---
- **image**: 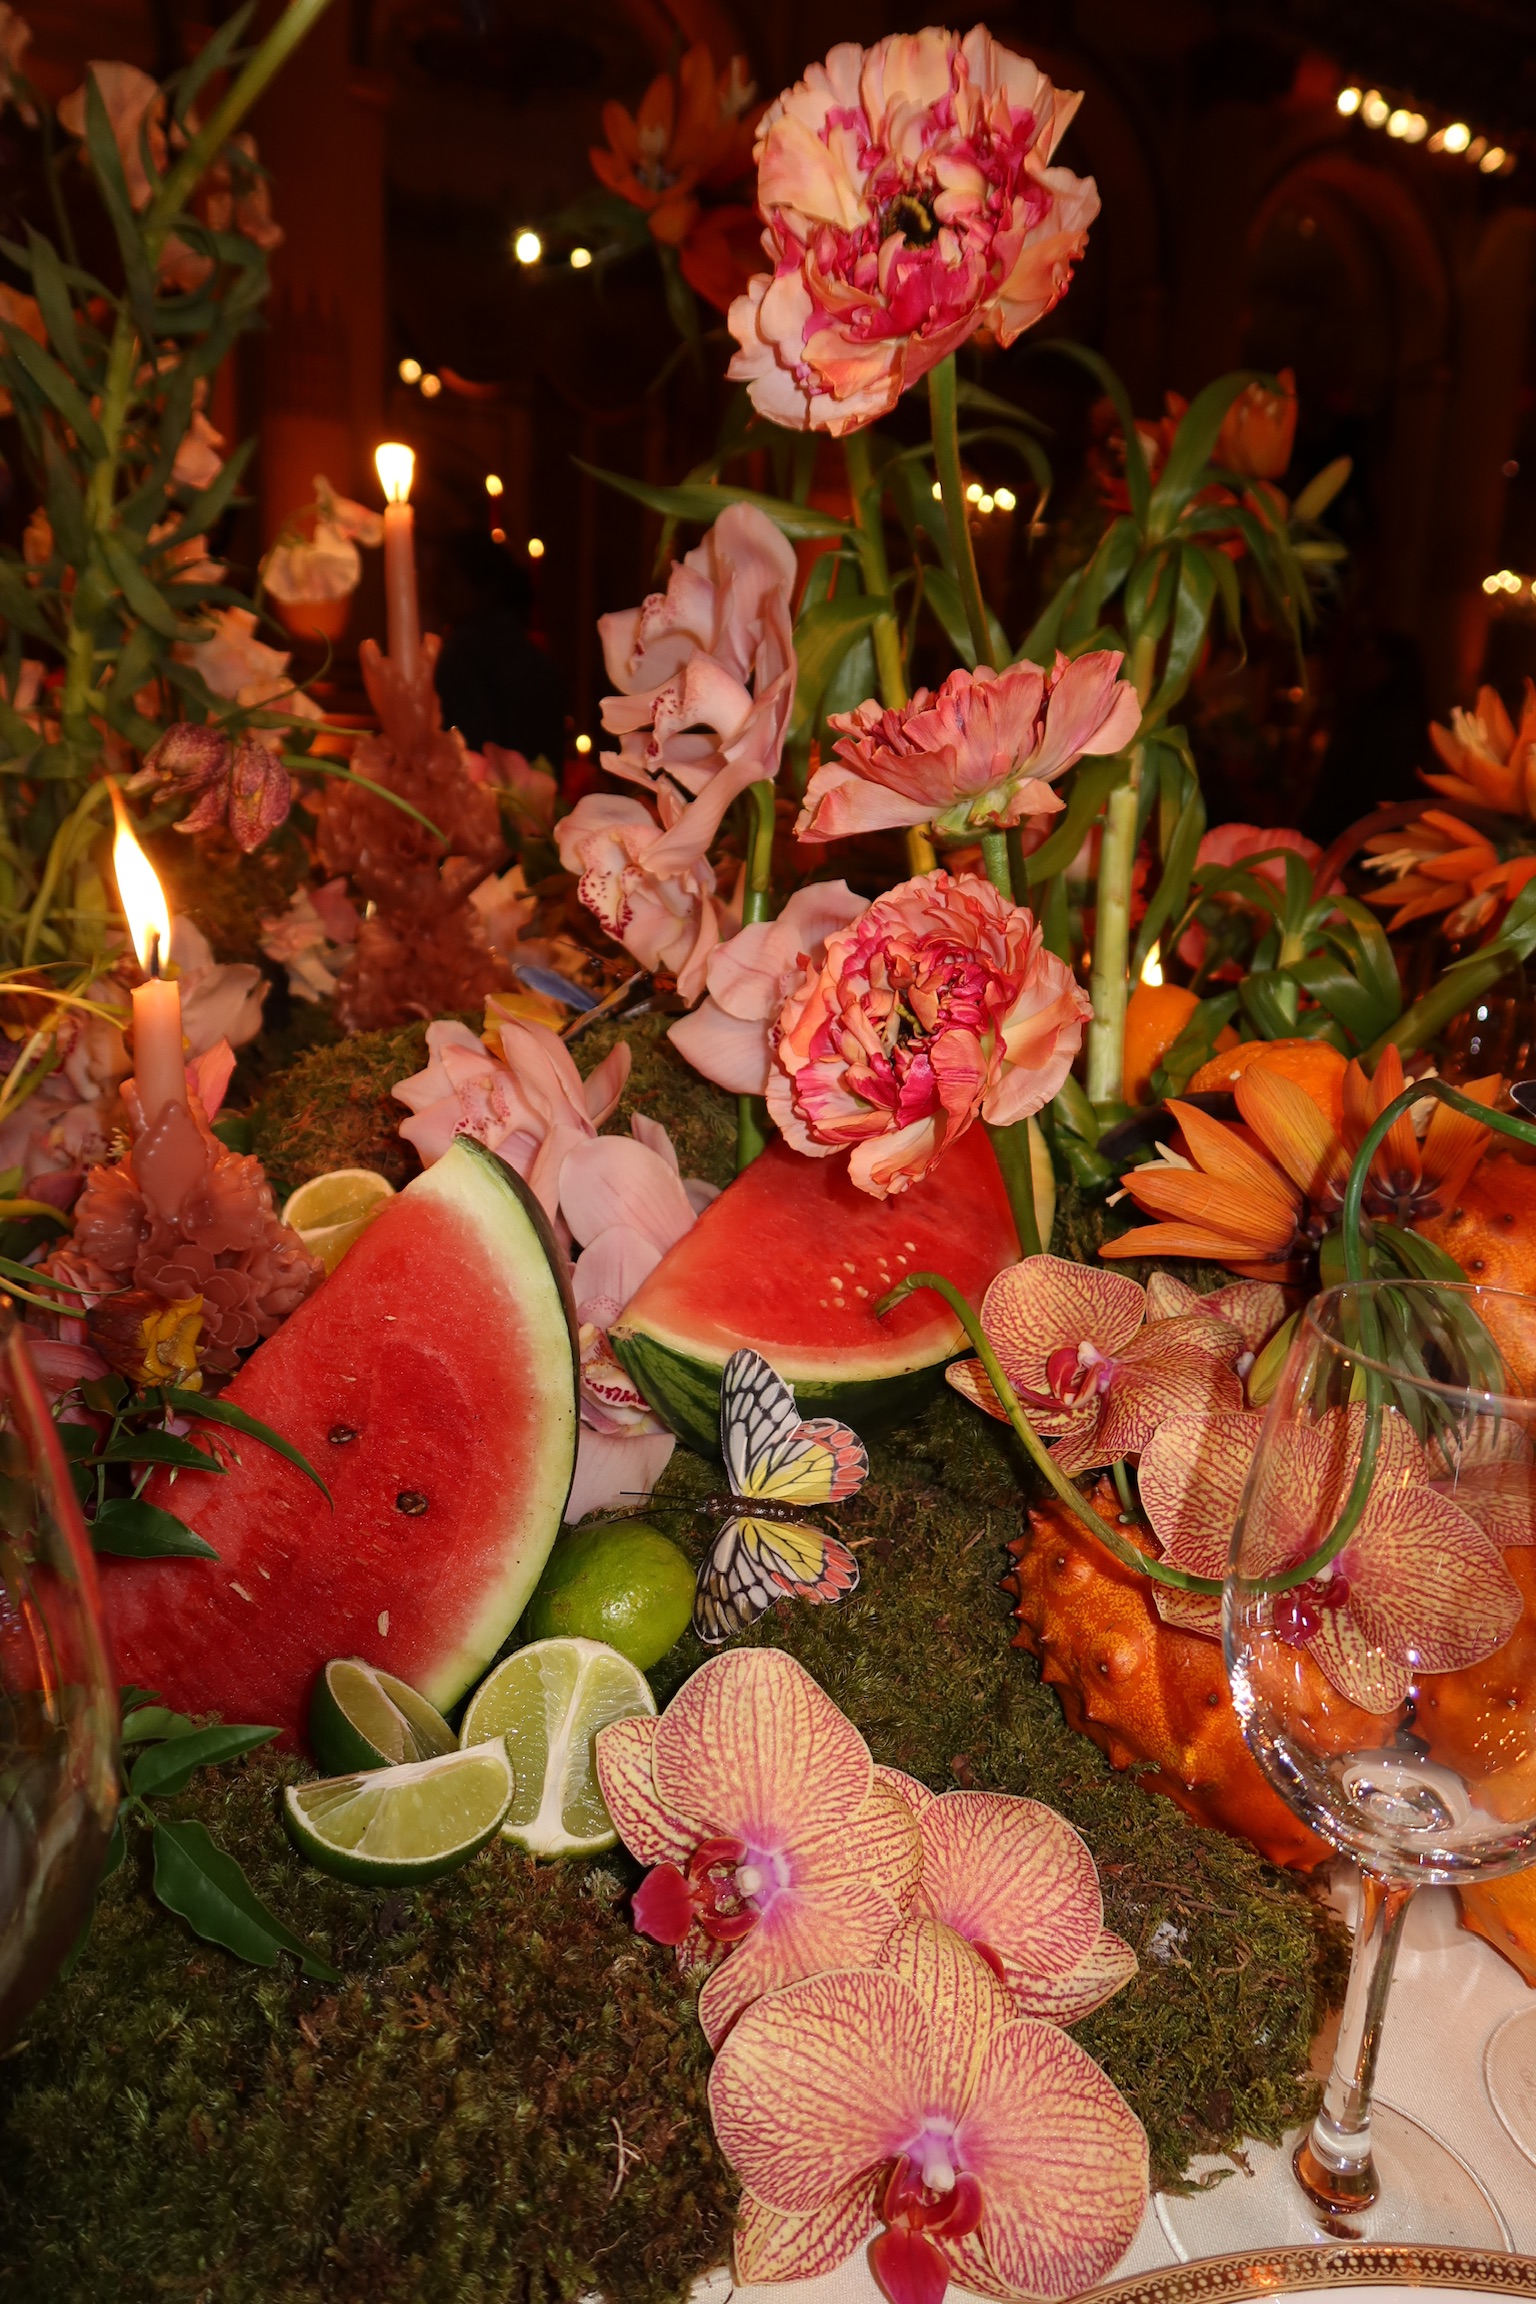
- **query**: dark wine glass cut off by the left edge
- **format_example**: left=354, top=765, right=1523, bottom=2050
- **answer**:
left=0, top=1297, right=117, bottom=2044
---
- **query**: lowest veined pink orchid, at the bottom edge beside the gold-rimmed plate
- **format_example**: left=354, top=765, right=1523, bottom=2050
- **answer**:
left=709, top=1919, right=1147, bottom=2304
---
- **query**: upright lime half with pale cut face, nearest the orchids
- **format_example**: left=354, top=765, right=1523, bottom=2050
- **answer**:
left=469, top=1640, right=656, bottom=1857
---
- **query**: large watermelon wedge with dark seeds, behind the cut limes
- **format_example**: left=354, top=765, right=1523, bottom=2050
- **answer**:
left=99, top=1136, right=576, bottom=1737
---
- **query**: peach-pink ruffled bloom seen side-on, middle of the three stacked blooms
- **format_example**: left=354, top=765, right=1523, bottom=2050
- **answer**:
left=794, top=647, right=1142, bottom=841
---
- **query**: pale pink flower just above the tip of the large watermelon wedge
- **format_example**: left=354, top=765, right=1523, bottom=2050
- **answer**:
left=391, top=1016, right=629, bottom=1221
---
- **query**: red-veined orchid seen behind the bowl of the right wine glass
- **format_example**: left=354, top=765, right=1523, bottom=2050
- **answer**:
left=1138, top=1408, right=1522, bottom=1712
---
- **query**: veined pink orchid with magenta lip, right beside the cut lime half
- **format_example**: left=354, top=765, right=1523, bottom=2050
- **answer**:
left=596, top=1647, right=919, bottom=2048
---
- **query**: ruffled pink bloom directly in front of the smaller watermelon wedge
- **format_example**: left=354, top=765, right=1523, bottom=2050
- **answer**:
left=767, top=871, right=1092, bottom=1200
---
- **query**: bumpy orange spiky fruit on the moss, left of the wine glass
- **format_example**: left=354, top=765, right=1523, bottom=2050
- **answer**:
left=1006, top=1481, right=1338, bottom=1871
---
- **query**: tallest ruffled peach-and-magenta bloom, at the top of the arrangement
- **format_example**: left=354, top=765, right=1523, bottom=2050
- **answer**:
left=730, top=25, right=1098, bottom=433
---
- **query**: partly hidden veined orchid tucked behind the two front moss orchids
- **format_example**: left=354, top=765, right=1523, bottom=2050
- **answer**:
left=884, top=1769, right=1135, bottom=2023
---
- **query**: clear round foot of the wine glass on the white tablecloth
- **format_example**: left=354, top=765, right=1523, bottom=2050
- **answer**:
left=1156, top=2101, right=1513, bottom=2263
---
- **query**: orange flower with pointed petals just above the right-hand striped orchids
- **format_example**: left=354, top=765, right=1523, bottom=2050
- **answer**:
left=1098, top=1048, right=1504, bottom=1281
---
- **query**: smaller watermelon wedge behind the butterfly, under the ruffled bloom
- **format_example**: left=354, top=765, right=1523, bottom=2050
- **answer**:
left=613, top=1129, right=1018, bottom=1456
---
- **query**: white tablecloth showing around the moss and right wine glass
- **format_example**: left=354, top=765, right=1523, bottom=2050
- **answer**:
left=695, top=1889, right=1536, bottom=2304
